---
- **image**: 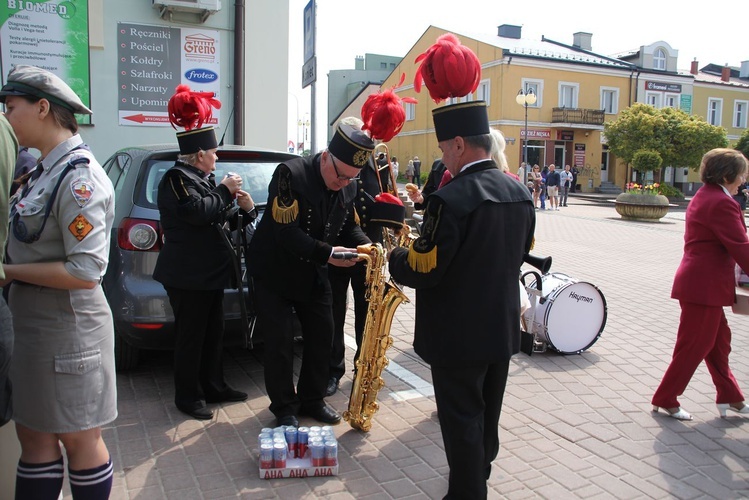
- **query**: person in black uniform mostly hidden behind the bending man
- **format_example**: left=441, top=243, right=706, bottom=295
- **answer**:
left=325, top=153, right=387, bottom=396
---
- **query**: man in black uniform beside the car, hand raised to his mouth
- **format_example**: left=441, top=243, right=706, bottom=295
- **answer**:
left=153, top=90, right=257, bottom=420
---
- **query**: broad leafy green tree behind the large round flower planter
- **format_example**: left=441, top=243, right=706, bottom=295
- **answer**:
left=604, top=103, right=728, bottom=184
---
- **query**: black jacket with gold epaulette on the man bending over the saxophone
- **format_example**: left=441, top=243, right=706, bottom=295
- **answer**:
left=247, top=154, right=369, bottom=301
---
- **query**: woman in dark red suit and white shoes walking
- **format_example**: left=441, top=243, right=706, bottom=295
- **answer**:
left=652, top=149, right=749, bottom=420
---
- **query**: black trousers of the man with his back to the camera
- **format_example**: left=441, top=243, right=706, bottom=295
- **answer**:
left=432, top=360, right=510, bottom=500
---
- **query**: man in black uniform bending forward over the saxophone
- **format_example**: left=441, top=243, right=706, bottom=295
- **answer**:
left=247, top=123, right=374, bottom=426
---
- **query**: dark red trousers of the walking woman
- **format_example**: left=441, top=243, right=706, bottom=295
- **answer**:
left=653, top=301, right=744, bottom=408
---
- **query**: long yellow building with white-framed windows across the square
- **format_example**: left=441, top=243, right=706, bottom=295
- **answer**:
left=358, top=25, right=749, bottom=193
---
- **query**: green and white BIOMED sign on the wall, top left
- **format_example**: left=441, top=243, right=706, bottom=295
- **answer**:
left=0, top=0, right=91, bottom=124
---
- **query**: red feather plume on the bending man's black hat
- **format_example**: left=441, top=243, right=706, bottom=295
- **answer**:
left=361, top=73, right=418, bottom=142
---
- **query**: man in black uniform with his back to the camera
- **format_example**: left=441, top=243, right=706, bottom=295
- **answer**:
left=389, top=101, right=535, bottom=499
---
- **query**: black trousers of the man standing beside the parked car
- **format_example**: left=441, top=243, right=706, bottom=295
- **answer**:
left=164, top=287, right=228, bottom=408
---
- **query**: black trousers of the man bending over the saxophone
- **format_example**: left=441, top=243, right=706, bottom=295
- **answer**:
left=255, top=278, right=333, bottom=418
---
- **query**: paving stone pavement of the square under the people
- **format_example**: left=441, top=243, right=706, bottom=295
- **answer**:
left=71, top=198, right=749, bottom=500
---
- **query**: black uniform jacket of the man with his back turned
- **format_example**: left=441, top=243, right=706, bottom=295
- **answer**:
left=389, top=160, right=536, bottom=366
